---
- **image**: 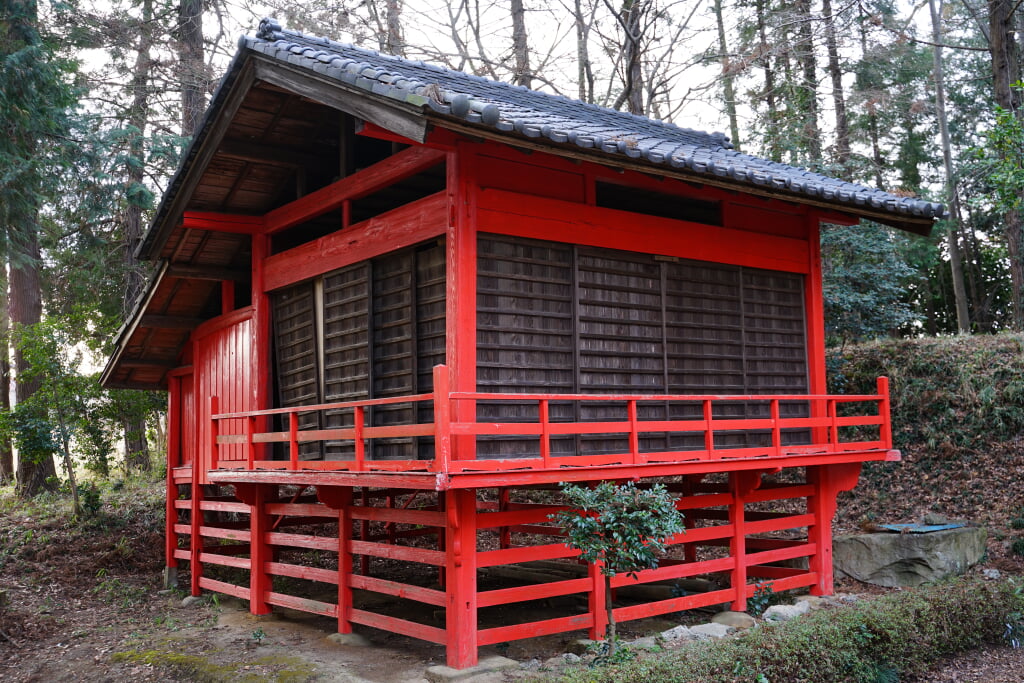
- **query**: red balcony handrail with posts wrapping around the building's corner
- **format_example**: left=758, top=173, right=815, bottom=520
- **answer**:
left=203, top=366, right=892, bottom=472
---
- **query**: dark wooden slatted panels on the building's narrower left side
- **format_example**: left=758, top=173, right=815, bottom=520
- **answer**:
left=271, top=240, right=445, bottom=460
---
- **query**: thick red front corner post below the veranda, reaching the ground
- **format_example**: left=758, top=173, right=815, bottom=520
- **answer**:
left=444, top=489, right=477, bottom=669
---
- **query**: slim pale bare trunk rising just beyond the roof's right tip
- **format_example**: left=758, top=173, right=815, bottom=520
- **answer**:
left=929, top=0, right=971, bottom=334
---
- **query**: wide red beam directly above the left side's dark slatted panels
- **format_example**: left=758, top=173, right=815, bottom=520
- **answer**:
left=263, top=192, right=446, bottom=291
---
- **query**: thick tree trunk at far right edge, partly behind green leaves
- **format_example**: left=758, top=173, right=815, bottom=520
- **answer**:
left=988, top=0, right=1024, bottom=330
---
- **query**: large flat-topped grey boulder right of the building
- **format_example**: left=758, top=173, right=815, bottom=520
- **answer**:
left=833, top=527, right=986, bottom=588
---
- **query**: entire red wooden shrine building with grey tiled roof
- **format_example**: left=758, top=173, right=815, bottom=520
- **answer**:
left=104, top=20, right=942, bottom=668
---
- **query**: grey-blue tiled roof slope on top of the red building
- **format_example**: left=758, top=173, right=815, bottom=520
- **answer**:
left=240, top=19, right=944, bottom=220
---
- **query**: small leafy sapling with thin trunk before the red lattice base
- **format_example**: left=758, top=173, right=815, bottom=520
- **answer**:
left=550, top=481, right=685, bottom=657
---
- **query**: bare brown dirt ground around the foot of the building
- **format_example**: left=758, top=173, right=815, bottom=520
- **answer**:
left=0, top=483, right=1024, bottom=683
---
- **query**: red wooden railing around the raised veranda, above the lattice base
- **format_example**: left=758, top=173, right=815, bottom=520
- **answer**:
left=210, top=366, right=892, bottom=472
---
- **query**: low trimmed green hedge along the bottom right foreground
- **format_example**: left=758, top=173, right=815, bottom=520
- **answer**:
left=565, top=581, right=1024, bottom=683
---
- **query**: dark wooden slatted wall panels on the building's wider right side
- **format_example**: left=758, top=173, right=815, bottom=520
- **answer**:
left=477, top=233, right=808, bottom=458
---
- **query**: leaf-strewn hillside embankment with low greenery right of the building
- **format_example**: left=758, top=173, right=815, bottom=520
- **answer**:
left=829, top=334, right=1024, bottom=571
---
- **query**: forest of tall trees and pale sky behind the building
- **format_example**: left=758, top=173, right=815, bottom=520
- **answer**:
left=0, top=0, right=1024, bottom=505
